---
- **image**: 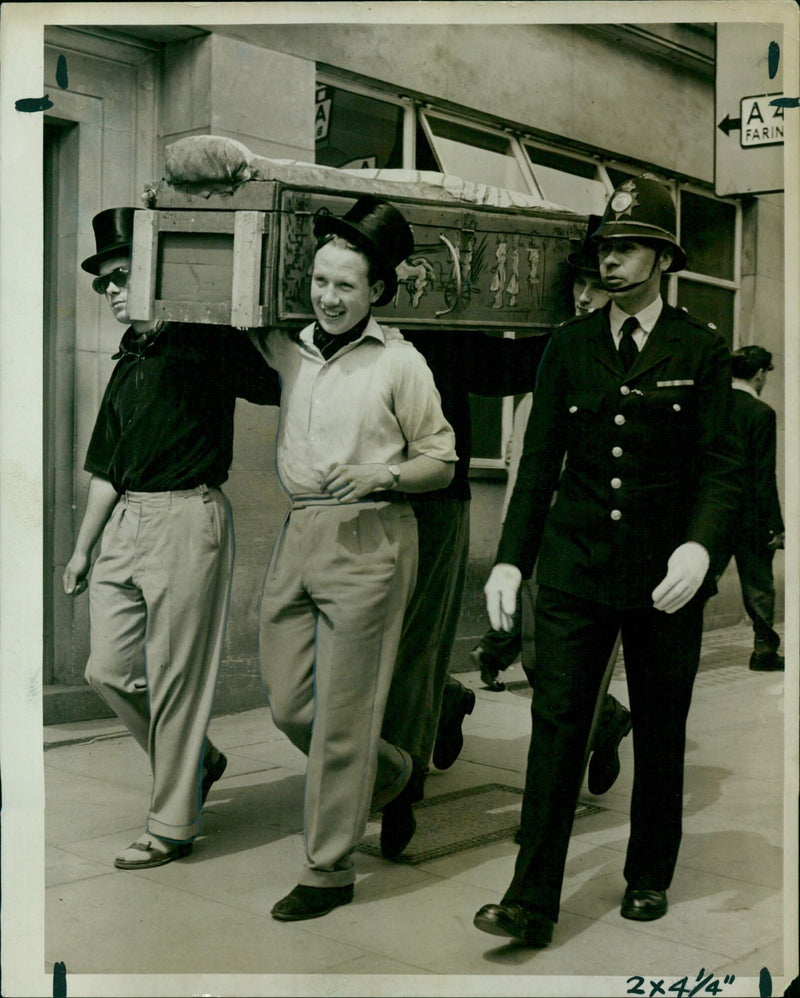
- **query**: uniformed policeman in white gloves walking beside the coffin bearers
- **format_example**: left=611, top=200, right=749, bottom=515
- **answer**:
left=475, top=175, right=739, bottom=946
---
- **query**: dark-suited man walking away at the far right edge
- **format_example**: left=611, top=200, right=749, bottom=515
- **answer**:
left=721, top=345, right=784, bottom=672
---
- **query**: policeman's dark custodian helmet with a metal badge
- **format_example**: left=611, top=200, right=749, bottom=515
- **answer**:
left=592, top=173, right=686, bottom=273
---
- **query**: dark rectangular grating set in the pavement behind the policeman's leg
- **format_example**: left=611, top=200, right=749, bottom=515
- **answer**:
left=358, top=783, right=605, bottom=866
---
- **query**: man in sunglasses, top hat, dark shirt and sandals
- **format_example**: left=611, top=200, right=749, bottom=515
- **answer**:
left=63, top=208, right=280, bottom=870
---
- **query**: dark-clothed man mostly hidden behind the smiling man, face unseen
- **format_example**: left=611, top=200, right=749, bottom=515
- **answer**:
left=381, top=329, right=547, bottom=859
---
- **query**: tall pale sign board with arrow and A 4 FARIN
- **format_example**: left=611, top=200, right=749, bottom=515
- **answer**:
left=714, top=21, right=785, bottom=197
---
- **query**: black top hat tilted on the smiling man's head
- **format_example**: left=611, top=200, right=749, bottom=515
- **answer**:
left=314, top=195, right=414, bottom=305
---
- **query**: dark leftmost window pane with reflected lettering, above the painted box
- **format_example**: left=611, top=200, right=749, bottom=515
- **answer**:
left=314, top=84, right=403, bottom=169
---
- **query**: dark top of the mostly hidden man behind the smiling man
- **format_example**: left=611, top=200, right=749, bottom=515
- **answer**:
left=403, top=329, right=550, bottom=500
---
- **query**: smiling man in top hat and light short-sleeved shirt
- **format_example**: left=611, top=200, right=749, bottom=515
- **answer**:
left=253, top=197, right=456, bottom=921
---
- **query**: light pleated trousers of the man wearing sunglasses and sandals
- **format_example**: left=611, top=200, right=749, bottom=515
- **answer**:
left=86, top=486, right=233, bottom=842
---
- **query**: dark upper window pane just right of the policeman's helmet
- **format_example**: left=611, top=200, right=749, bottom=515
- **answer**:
left=681, top=190, right=736, bottom=281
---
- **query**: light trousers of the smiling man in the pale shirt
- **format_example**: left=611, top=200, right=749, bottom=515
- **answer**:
left=259, top=502, right=417, bottom=887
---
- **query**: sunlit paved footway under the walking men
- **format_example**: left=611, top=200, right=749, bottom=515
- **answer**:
left=39, top=624, right=797, bottom=998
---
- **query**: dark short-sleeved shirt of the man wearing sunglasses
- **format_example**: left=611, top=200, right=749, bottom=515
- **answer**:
left=84, top=323, right=280, bottom=492
